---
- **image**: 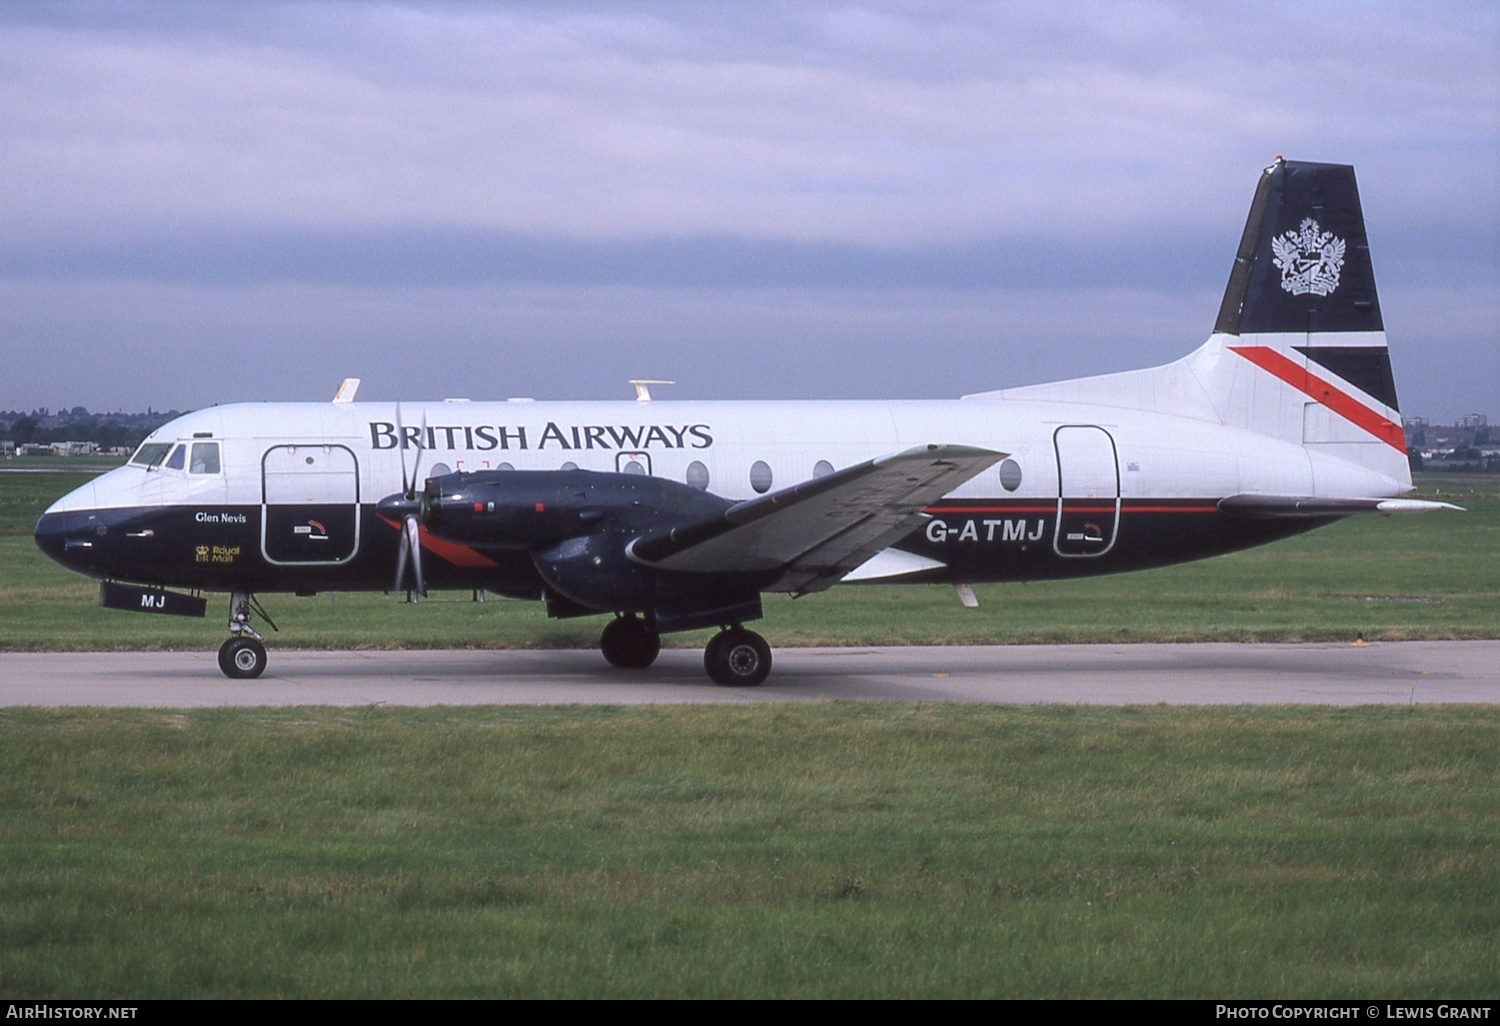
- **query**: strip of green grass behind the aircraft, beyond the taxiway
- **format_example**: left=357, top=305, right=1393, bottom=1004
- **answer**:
left=0, top=474, right=1500, bottom=651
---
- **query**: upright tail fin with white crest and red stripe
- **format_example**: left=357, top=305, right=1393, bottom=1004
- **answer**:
left=1187, top=159, right=1412, bottom=485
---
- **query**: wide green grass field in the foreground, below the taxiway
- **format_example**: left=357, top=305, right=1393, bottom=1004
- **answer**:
left=0, top=704, right=1500, bottom=998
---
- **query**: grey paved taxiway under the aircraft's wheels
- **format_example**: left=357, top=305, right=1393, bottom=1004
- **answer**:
left=0, top=641, right=1500, bottom=708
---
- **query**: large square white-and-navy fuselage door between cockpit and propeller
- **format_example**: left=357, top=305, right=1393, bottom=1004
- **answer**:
left=261, top=444, right=360, bottom=566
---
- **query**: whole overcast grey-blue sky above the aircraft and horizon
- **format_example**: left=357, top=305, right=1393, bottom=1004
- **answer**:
left=0, top=0, right=1500, bottom=420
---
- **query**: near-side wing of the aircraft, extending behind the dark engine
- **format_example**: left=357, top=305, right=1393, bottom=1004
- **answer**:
left=629, top=446, right=1007, bottom=594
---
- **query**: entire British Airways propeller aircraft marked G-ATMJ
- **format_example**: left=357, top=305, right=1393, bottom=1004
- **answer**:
left=36, top=159, right=1443, bottom=686
